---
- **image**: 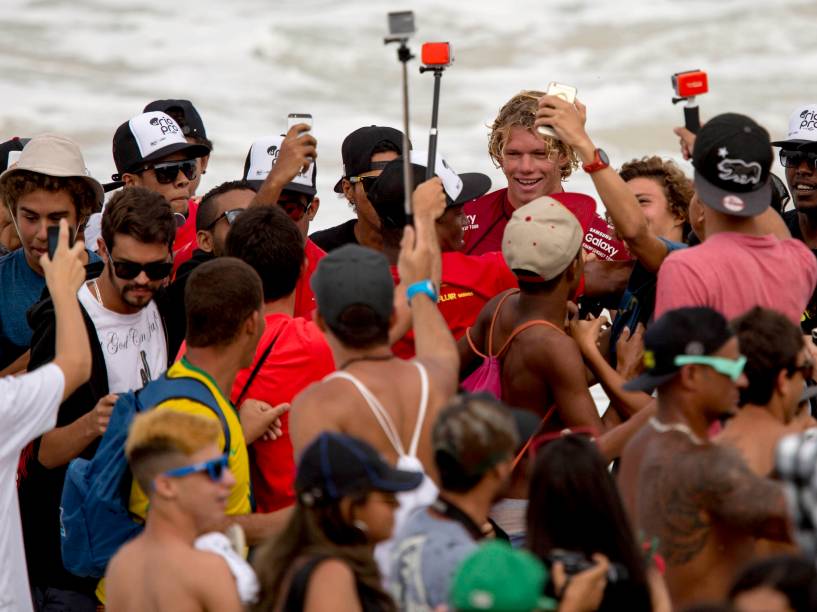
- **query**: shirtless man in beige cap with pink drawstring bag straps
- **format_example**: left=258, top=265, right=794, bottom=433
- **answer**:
left=459, top=196, right=604, bottom=431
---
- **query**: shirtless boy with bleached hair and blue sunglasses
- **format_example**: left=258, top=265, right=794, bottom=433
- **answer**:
left=105, top=410, right=242, bottom=612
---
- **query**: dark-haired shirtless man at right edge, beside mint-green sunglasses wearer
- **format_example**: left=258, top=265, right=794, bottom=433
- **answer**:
left=715, top=307, right=817, bottom=476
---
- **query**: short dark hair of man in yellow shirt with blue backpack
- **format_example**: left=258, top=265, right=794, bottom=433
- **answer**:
left=184, top=257, right=264, bottom=348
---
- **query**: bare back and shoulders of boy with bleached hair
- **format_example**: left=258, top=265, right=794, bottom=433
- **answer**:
left=105, top=533, right=242, bottom=612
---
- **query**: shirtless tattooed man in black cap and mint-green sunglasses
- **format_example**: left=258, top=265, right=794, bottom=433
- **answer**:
left=619, top=307, right=791, bottom=609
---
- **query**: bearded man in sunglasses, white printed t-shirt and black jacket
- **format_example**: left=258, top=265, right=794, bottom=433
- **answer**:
left=19, top=187, right=178, bottom=610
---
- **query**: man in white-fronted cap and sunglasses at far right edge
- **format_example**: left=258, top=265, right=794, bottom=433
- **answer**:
left=772, top=104, right=817, bottom=332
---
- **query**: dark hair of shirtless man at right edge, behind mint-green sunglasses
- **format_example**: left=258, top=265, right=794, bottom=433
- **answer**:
left=732, top=306, right=804, bottom=406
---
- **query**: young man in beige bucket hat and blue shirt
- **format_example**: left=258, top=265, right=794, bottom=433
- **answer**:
left=0, top=134, right=103, bottom=373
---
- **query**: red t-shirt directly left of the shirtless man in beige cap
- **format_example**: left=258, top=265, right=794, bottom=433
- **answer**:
left=391, top=252, right=517, bottom=359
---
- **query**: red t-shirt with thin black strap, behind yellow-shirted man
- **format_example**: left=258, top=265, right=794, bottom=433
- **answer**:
left=230, top=313, right=335, bottom=512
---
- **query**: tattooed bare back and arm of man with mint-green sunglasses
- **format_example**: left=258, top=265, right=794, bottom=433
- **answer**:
left=619, top=425, right=790, bottom=609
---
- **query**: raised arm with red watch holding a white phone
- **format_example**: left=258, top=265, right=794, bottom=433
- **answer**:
left=535, top=96, right=668, bottom=272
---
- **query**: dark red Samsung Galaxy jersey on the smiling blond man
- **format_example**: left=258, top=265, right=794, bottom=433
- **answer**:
left=463, top=187, right=631, bottom=261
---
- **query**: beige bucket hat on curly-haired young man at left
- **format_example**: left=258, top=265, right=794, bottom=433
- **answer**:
left=0, top=134, right=105, bottom=204
